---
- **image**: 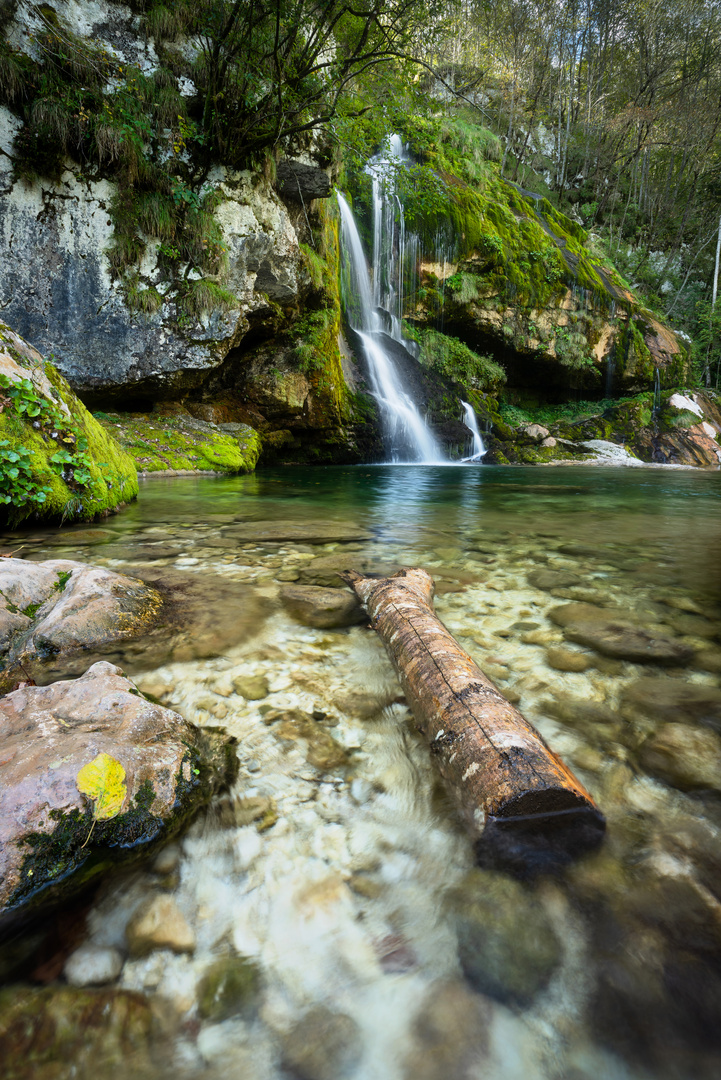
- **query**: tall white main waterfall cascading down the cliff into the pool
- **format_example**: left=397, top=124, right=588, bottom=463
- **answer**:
left=338, top=190, right=444, bottom=463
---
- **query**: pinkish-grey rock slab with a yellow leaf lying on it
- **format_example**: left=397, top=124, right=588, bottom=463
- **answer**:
left=0, top=661, right=236, bottom=919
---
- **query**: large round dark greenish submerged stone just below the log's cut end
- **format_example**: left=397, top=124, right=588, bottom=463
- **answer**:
left=450, top=869, right=560, bottom=1004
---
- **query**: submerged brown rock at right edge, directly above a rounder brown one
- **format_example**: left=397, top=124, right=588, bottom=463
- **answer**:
left=621, top=676, right=721, bottom=730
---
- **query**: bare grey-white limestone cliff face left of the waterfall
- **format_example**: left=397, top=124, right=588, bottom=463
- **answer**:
left=0, top=134, right=300, bottom=395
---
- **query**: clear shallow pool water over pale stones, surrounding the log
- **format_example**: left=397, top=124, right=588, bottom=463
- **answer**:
left=4, top=465, right=721, bottom=1080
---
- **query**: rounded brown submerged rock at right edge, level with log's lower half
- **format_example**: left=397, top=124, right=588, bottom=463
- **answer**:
left=639, top=724, right=721, bottom=792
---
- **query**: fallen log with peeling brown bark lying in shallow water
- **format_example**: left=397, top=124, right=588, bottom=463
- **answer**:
left=343, top=569, right=604, bottom=867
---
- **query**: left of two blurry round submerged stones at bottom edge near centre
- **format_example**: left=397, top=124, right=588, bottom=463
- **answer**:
left=282, top=1005, right=363, bottom=1080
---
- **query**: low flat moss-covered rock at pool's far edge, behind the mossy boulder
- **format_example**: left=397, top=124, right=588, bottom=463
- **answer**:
left=97, top=413, right=261, bottom=473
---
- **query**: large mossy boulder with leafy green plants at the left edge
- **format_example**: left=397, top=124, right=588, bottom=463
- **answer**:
left=0, top=323, right=138, bottom=524
